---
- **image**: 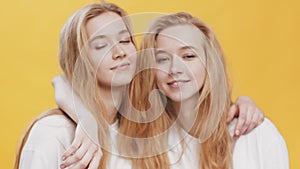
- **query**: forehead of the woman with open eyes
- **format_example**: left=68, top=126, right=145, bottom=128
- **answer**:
left=156, top=24, right=205, bottom=50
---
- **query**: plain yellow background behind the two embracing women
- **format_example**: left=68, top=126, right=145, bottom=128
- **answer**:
left=0, top=0, right=300, bottom=169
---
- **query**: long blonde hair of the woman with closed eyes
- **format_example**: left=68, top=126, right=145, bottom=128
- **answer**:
left=15, top=3, right=135, bottom=168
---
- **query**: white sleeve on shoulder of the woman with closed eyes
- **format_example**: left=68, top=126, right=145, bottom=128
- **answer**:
left=19, top=115, right=75, bottom=169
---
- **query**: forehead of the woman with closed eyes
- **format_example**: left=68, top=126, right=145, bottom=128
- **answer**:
left=86, top=12, right=127, bottom=37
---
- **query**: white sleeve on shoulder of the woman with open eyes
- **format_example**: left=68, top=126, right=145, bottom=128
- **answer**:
left=233, top=118, right=289, bottom=169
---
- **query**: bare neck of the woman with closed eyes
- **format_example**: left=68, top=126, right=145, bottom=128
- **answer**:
left=100, top=87, right=123, bottom=124
